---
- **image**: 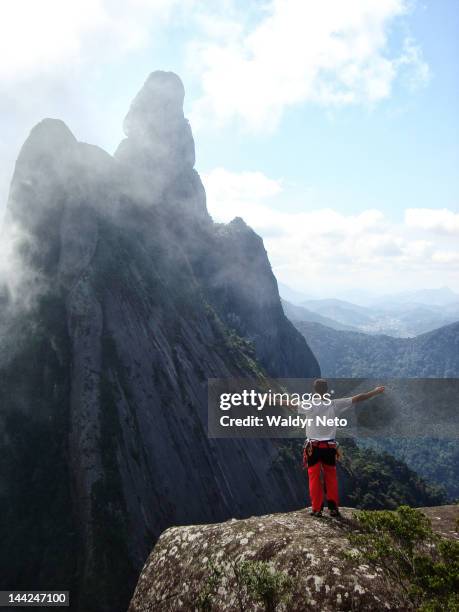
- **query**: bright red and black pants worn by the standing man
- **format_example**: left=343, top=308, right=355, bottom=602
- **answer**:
left=308, top=447, right=338, bottom=512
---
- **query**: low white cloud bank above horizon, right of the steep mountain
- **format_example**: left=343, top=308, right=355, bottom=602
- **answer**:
left=203, top=168, right=459, bottom=294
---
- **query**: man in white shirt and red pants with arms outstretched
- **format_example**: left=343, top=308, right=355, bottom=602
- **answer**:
left=282, top=378, right=384, bottom=517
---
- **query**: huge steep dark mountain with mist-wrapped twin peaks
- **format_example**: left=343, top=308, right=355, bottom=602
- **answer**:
left=0, top=72, right=319, bottom=612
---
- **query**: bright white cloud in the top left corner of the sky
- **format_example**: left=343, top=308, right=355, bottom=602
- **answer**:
left=0, top=0, right=190, bottom=81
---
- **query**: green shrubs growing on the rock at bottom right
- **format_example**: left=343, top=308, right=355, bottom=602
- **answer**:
left=349, top=506, right=459, bottom=612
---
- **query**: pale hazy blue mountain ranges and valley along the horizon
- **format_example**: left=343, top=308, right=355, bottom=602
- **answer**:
left=283, top=290, right=459, bottom=338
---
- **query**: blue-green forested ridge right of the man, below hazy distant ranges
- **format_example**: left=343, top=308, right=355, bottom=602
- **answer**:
left=292, top=318, right=459, bottom=500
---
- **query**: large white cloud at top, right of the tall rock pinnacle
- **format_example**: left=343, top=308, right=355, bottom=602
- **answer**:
left=190, top=0, right=429, bottom=129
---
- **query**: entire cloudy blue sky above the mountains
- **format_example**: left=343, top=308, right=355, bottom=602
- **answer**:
left=0, top=0, right=459, bottom=296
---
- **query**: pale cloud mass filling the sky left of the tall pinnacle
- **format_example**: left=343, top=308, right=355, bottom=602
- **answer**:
left=0, top=0, right=201, bottom=206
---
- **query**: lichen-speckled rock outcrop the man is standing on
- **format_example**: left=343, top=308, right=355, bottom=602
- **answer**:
left=129, top=506, right=459, bottom=612
